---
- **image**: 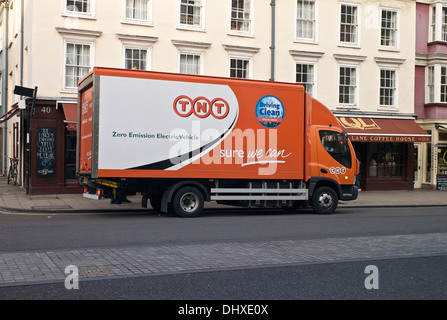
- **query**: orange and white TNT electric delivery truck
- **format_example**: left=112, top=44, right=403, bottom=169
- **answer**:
left=77, top=67, right=359, bottom=217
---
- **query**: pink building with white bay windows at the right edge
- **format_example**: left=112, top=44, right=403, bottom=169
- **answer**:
left=415, top=1, right=447, bottom=188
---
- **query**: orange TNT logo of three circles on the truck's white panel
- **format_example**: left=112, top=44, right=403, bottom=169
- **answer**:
left=174, top=96, right=230, bottom=119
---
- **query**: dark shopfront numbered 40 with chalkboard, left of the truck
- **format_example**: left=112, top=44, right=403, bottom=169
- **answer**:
left=22, top=99, right=82, bottom=194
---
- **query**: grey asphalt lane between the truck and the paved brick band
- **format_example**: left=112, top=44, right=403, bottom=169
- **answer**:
left=0, top=207, right=447, bottom=252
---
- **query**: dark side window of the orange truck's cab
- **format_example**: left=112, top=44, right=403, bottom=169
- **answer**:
left=320, top=130, right=352, bottom=168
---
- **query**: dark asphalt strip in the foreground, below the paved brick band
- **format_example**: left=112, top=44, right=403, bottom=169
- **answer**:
left=0, top=256, right=447, bottom=300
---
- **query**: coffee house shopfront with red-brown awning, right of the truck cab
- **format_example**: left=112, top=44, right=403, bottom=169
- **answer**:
left=338, top=116, right=431, bottom=190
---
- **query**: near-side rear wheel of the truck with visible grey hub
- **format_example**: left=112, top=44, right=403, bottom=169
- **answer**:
left=172, top=186, right=204, bottom=218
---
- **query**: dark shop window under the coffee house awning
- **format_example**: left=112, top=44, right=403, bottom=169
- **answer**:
left=368, top=142, right=406, bottom=178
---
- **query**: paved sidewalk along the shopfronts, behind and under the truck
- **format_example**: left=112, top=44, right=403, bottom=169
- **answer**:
left=0, top=176, right=447, bottom=213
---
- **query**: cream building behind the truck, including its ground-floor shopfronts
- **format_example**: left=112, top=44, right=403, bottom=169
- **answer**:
left=0, top=0, right=430, bottom=193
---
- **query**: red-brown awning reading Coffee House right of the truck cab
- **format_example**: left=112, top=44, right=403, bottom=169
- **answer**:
left=337, top=116, right=431, bottom=142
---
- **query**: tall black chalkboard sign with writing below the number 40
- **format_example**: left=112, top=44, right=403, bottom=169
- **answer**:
left=36, top=127, right=56, bottom=179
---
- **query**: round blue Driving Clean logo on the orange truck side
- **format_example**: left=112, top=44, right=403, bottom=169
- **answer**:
left=256, top=96, right=284, bottom=128
